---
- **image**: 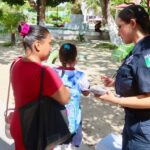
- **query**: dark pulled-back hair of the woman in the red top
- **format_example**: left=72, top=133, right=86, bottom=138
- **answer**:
left=18, top=25, right=49, bottom=50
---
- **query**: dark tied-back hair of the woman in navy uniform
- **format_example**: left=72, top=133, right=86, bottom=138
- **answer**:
left=118, top=4, right=150, bottom=33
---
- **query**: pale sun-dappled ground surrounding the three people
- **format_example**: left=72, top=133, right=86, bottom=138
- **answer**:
left=0, top=41, right=123, bottom=150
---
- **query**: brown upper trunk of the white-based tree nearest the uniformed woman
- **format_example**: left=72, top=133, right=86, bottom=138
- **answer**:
left=100, top=0, right=110, bottom=25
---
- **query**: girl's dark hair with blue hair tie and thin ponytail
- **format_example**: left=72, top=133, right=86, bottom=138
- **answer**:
left=59, top=43, right=77, bottom=76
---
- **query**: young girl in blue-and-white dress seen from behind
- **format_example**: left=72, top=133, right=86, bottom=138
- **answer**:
left=54, top=43, right=89, bottom=150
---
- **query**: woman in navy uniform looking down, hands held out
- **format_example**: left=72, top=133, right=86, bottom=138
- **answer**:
left=99, top=5, right=150, bottom=150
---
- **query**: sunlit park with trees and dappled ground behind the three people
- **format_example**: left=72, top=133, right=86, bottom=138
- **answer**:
left=0, top=0, right=149, bottom=150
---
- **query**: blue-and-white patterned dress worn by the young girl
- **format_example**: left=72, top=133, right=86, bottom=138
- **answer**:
left=54, top=67, right=89, bottom=134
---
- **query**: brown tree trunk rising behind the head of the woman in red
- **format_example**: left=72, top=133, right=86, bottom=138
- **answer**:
left=39, top=0, right=47, bottom=26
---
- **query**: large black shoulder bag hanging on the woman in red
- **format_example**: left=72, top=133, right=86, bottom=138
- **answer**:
left=19, top=68, right=71, bottom=150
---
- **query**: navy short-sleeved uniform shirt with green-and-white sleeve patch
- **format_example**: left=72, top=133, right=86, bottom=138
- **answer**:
left=115, top=36, right=150, bottom=116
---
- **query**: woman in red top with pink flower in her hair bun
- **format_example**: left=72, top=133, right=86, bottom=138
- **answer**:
left=10, top=24, right=70, bottom=150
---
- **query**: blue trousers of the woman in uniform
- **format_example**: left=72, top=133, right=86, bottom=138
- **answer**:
left=122, top=116, right=150, bottom=150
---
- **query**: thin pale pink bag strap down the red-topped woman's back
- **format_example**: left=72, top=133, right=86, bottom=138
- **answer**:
left=4, top=57, right=20, bottom=119
